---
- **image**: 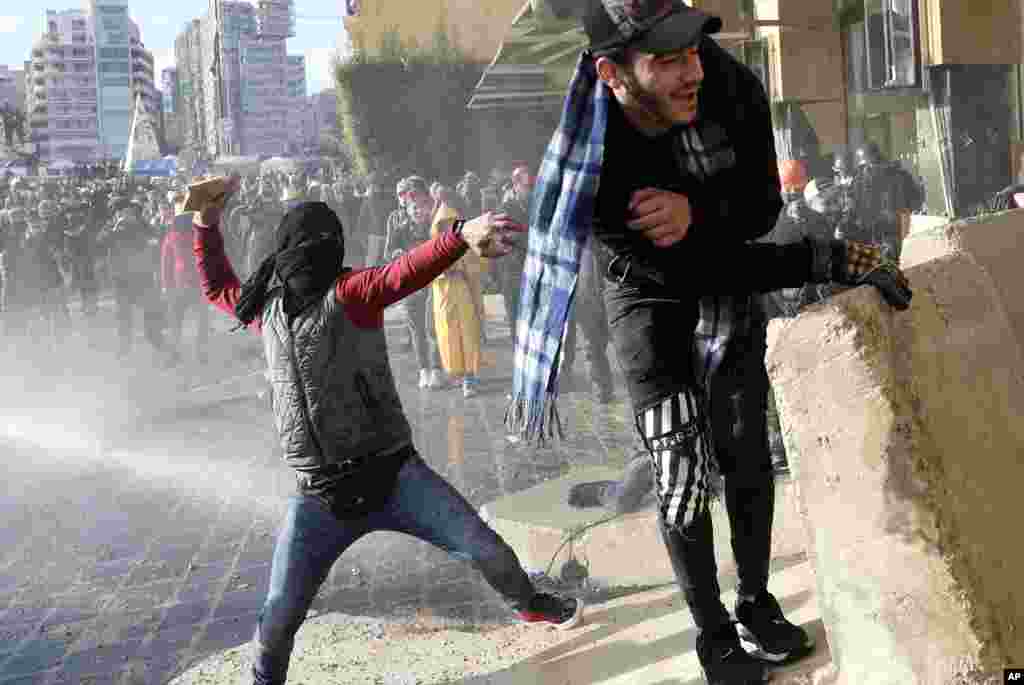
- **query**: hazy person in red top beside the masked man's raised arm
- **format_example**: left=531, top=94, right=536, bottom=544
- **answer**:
left=160, top=192, right=210, bottom=363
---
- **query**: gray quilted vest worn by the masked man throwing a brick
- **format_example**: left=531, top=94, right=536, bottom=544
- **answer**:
left=263, top=288, right=413, bottom=474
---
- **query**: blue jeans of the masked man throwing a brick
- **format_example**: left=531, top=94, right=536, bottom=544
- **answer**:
left=253, top=454, right=534, bottom=685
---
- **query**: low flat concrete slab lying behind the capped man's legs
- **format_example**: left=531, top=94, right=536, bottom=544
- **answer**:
left=480, top=467, right=806, bottom=586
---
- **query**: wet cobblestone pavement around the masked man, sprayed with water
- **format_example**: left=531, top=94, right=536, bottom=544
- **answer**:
left=0, top=312, right=634, bottom=685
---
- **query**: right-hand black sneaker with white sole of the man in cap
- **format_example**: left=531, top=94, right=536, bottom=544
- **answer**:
left=736, top=590, right=814, bottom=663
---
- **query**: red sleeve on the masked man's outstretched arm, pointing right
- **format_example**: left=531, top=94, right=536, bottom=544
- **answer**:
left=335, top=225, right=468, bottom=329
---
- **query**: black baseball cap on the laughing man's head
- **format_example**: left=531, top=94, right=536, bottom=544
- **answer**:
left=584, top=0, right=722, bottom=56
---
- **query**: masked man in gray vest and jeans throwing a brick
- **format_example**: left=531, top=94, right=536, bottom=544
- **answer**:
left=187, top=176, right=583, bottom=685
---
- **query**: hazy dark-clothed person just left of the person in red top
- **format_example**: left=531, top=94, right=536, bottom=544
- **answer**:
left=98, top=200, right=169, bottom=367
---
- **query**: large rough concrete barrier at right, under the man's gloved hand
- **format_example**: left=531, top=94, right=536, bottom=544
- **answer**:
left=768, top=248, right=1024, bottom=685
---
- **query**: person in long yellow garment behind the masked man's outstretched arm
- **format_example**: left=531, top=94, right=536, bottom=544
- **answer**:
left=430, top=187, right=484, bottom=397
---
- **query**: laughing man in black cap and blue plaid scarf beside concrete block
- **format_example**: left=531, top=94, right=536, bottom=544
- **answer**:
left=506, top=0, right=910, bottom=685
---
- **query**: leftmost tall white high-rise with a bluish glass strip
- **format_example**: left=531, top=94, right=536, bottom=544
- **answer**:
left=26, top=0, right=159, bottom=162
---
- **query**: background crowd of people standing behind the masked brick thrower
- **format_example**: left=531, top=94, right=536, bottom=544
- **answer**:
left=0, top=167, right=530, bottom=382
